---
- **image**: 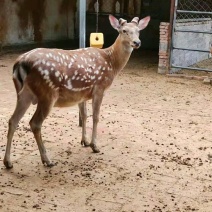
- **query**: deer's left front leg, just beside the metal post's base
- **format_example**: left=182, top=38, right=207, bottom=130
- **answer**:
left=78, top=102, right=90, bottom=147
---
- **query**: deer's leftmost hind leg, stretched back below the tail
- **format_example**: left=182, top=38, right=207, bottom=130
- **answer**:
left=3, top=87, right=33, bottom=169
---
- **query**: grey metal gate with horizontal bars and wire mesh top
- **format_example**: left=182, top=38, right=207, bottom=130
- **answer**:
left=170, top=0, right=212, bottom=71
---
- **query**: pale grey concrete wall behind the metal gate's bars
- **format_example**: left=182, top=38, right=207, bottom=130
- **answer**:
left=172, top=20, right=212, bottom=67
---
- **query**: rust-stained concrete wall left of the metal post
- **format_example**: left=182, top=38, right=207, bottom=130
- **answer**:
left=0, top=0, right=77, bottom=47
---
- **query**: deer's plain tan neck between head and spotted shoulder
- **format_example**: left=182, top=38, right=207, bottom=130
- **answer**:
left=107, top=35, right=133, bottom=74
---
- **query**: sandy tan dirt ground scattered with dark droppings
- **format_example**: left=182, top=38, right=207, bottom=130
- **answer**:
left=0, top=52, right=212, bottom=212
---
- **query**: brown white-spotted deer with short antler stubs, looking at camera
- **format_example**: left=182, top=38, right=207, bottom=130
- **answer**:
left=3, top=15, right=150, bottom=168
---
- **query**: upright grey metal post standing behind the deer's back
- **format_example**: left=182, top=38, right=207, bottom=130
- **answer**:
left=79, top=0, right=86, bottom=127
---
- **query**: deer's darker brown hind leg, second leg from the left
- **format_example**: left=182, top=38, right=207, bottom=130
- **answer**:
left=30, top=100, right=54, bottom=167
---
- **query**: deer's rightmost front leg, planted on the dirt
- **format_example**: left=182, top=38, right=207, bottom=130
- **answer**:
left=90, top=91, right=103, bottom=153
